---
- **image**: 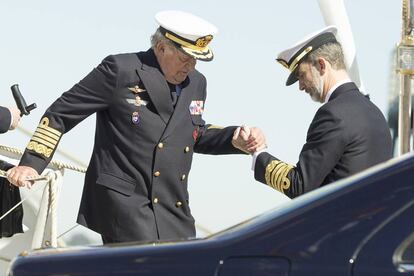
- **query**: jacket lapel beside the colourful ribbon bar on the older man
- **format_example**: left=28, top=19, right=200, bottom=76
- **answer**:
left=163, top=74, right=196, bottom=138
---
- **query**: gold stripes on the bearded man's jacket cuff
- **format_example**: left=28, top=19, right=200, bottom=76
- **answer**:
left=265, top=160, right=293, bottom=193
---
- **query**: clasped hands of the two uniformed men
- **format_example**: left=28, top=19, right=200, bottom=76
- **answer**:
left=231, top=126, right=267, bottom=154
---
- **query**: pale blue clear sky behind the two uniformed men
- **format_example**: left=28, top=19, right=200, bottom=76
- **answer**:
left=0, top=0, right=401, bottom=242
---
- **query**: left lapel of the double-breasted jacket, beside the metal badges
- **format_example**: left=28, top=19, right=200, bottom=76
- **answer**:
left=137, top=50, right=174, bottom=124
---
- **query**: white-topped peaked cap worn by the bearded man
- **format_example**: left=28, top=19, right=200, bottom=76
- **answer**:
left=276, top=26, right=338, bottom=86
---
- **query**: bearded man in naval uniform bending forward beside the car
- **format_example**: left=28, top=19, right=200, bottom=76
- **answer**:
left=236, top=26, right=392, bottom=198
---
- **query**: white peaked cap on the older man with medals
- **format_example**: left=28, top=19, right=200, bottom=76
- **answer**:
left=155, top=11, right=218, bottom=61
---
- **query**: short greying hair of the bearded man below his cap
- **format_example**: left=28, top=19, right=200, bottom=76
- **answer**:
left=304, top=42, right=346, bottom=70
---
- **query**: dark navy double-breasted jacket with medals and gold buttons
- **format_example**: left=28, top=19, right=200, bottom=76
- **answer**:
left=20, top=50, right=242, bottom=241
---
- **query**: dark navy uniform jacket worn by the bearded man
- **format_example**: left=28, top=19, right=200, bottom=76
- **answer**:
left=255, top=83, right=392, bottom=198
